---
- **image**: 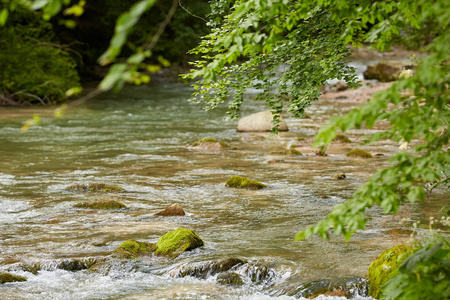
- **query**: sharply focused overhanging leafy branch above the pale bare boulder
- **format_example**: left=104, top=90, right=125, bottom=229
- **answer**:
left=184, top=1, right=358, bottom=131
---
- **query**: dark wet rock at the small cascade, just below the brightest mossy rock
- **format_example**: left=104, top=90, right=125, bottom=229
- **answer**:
left=171, top=258, right=246, bottom=279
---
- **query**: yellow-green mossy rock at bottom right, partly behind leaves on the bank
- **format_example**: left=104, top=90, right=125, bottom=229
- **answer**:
left=367, top=245, right=414, bottom=299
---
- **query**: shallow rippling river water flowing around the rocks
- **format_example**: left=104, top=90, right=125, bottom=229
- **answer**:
left=0, top=82, right=444, bottom=299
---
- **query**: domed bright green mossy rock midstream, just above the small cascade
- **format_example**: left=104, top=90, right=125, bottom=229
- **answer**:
left=155, top=228, right=204, bottom=258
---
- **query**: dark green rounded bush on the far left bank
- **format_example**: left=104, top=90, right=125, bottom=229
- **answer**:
left=0, top=7, right=79, bottom=104
